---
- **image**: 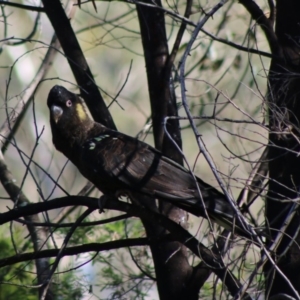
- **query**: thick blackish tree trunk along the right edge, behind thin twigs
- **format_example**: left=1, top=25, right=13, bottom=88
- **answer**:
left=264, top=0, right=300, bottom=299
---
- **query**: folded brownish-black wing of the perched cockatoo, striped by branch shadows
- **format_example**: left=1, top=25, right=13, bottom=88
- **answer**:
left=83, top=130, right=233, bottom=217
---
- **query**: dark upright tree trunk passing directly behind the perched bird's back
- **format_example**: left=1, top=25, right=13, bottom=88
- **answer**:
left=137, top=1, right=199, bottom=300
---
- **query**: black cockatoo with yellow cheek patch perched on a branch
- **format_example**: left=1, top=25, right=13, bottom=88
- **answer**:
left=47, top=86, right=252, bottom=238
